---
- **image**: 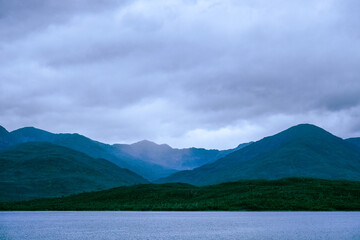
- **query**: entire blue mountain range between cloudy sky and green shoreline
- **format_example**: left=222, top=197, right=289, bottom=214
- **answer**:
left=0, top=124, right=360, bottom=201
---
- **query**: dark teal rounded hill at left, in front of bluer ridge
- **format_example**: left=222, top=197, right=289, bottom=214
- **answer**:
left=0, top=142, right=147, bottom=201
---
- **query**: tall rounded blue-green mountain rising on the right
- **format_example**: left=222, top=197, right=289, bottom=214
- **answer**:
left=158, top=124, right=360, bottom=185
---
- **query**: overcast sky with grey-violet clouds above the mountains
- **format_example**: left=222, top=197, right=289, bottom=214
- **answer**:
left=0, top=0, right=360, bottom=149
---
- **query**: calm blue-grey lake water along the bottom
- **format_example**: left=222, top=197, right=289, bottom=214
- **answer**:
left=0, top=212, right=360, bottom=240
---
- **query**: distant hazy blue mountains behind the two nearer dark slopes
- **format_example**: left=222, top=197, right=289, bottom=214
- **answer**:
left=0, top=126, right=247, bottom=180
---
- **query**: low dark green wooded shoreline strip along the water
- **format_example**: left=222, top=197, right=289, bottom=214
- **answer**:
left=0, top=178, right=360, bottom=211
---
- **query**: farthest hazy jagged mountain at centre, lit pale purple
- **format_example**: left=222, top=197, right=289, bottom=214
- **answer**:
left=114, top=140, right=250, bottom=170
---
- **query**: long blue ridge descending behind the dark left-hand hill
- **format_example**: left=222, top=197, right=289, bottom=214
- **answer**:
left=0, top=127, right=175, bottom=180
